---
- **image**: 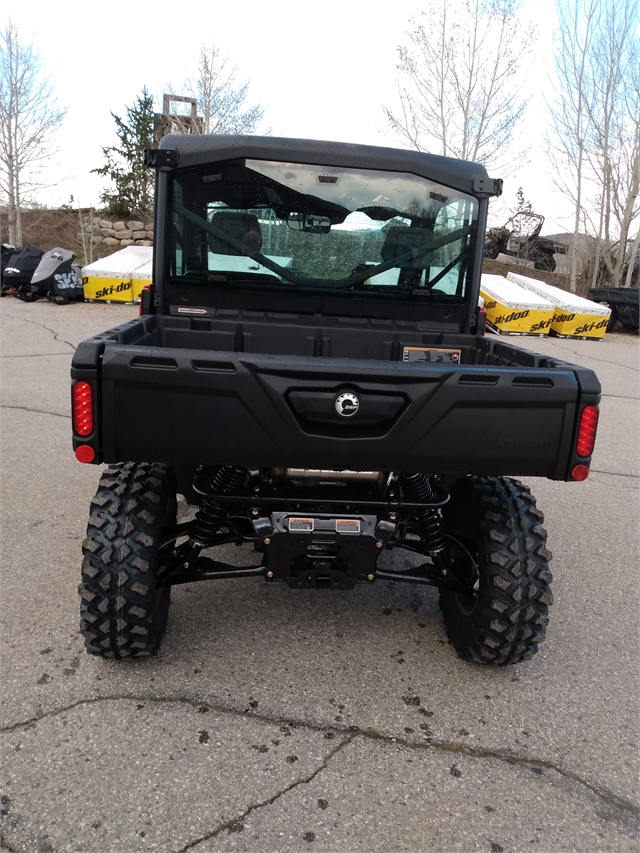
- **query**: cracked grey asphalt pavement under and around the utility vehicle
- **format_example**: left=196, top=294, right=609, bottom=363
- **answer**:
left=0, top=298, right=640, bottom=853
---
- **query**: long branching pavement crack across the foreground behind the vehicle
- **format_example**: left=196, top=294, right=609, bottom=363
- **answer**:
left=0, top=694, right=640, bottom=824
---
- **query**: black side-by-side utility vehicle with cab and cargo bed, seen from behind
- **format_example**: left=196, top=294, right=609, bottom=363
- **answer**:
left=72, top=135, right=600, bottom=664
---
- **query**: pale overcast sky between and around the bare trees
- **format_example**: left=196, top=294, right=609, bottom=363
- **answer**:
left=3, top=0, right=567, bottom=233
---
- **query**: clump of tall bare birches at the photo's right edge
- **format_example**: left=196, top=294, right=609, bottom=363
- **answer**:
left=549, top=0, right=640, bottom=291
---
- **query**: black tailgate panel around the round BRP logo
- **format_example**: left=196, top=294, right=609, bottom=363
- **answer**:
left=101, top=344, right=580, bottom=479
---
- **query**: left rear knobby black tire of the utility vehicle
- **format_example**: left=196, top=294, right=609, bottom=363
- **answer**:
left=78, top=462, right=176, bottom=658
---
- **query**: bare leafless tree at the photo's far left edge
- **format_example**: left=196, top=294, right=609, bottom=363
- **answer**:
left=0, top=21, right=66, bottom=245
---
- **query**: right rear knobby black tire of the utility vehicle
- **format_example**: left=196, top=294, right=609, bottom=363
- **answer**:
left=440, top=477, right=553, bottom=666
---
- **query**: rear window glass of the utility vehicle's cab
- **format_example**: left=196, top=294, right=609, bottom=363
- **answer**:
left=167, top=160, right=477, bottom=302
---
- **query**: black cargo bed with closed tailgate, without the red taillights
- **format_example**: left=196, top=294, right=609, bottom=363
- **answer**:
left=73, top=311, right=600, bottom=479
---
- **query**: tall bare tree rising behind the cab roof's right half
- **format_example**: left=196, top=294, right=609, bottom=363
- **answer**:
left=383, top=0, right=534, bottom=168
